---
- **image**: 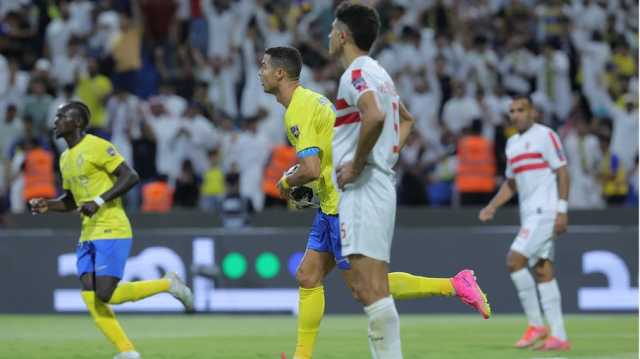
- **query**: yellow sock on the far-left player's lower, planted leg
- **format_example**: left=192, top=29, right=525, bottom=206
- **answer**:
left=82, top=291, right=134, bottom=352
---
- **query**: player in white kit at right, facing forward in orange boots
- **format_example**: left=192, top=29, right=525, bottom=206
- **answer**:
left=479, top=96, right=571, bottom=350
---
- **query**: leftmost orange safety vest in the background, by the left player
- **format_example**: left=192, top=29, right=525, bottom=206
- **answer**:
left=22, top=148, right=56, bottom=201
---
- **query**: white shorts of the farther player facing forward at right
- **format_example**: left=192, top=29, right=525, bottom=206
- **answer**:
left=511, top=214, right=556, bottom=266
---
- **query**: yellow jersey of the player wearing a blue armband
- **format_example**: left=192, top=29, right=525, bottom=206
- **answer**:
left=284, top=86, right=339, bottom=214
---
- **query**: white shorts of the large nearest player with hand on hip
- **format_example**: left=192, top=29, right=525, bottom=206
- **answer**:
left=339, top=166, right=396, bottom=263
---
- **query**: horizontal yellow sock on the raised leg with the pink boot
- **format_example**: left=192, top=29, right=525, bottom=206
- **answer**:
left=389, top=272, right=455, bottom=299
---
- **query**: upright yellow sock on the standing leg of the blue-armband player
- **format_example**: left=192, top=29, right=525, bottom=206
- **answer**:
left=293, top=286, right=324, bottom=359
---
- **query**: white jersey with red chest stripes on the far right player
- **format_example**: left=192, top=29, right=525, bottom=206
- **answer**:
left=506, top=124, right=567, bottom=221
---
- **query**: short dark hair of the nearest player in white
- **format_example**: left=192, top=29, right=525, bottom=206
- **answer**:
left=335, top=1, right=380, bottom=52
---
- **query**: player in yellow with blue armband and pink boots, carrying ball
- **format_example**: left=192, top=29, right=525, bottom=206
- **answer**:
left=259, top=47, right=490, bottom=359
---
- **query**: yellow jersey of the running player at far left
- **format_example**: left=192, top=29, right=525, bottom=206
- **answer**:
left=60, top=135, right=133, bottom=242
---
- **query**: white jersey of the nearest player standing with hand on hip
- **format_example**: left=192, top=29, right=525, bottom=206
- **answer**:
left=333, top=56, right=400, bottom=174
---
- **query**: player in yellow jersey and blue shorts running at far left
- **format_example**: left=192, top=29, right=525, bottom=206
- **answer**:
left=29, top=101, right=193, bottom=359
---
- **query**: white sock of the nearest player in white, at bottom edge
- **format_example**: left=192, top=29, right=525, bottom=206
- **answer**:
left=364, top=296, right=402, bottom=359
